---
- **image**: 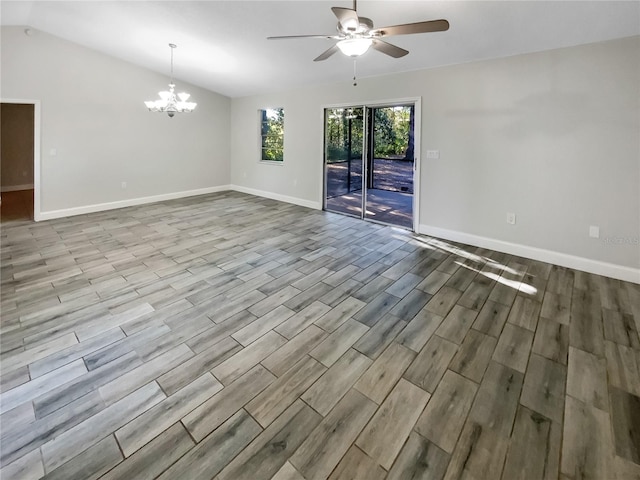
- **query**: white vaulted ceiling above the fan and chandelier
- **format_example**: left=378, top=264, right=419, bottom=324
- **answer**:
left=0, top=0, right=640, bottom=97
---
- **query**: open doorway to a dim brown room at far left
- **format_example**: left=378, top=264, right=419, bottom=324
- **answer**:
left=0, top=101, right=39, bottom=222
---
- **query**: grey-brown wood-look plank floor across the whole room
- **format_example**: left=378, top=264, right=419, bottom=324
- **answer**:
left=0, top=193, right=640, bottom=480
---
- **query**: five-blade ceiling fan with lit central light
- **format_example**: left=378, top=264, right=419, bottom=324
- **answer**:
left=267, top=0, right=449, bottom=62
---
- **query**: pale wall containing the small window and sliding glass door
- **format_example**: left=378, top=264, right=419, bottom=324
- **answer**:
left=231, top=37, right=640, bottom=281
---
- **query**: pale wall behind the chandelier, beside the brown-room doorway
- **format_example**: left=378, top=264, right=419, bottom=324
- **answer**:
left=1, top=27, right=231, bottom=217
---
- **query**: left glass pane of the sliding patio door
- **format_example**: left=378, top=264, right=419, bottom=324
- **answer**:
left=325, top=107, right=364, bottom=217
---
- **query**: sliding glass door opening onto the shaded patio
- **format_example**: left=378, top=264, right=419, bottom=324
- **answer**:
left=324, top=102, right=417, bottom=230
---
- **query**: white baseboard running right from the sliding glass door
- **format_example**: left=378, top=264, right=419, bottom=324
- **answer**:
left=418, top=225, right=640, bottom=284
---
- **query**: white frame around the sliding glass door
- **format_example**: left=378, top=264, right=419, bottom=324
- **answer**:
left=319, top=97, right=422, bottom=233
